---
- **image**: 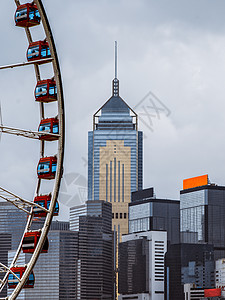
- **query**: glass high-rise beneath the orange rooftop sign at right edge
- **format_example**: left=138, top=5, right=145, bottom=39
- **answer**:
left=180, top=180, right=225, bottom=259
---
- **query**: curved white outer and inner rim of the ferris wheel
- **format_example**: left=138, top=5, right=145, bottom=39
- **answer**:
left=1, top=0, right=65, bottom=300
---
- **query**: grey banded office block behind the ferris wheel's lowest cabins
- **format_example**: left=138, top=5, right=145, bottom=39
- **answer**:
left=8, top=226, right=78, bottom=300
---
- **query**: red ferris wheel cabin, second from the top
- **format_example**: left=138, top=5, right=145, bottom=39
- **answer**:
left=27, top=40, right=51, bottom=64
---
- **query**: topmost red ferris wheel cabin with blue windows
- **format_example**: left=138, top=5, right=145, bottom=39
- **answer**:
left=15, top=3, right=41, bottom=27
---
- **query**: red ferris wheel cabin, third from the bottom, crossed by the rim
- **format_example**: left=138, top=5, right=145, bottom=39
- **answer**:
left=33, top=194, right=59, bottom=217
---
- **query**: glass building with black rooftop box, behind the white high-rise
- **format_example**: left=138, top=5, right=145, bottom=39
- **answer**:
left=129, top=188, right=180, bottom=244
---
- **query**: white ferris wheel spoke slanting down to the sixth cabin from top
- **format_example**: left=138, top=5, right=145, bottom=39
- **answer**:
left=0, top=187, right=49, bottom=215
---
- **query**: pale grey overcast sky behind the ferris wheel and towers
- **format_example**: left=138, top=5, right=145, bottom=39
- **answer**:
left=0, top=0, right=225, bottom=219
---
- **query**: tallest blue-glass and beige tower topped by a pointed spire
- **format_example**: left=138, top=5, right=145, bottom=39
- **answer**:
left=88, top=42, right=143, bottom=240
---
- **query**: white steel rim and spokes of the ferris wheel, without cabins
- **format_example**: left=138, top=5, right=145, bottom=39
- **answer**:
left=0, top=0, right=65, bottom=300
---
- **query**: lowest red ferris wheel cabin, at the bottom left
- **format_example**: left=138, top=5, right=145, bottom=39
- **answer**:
left=8, top=267, right=35, bottom=289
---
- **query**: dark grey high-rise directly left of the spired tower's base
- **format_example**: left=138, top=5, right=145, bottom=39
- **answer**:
left=70, top=200, right=114, bottom=300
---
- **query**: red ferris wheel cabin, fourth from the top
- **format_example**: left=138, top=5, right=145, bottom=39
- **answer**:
left=38, top=117, right=59, bottom=141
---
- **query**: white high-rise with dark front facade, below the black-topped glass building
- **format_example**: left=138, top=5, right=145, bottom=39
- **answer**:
left=119, top=231, right=167, bottom=300
